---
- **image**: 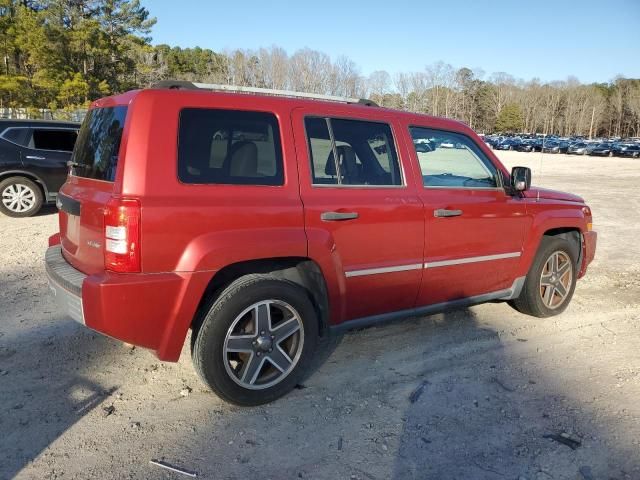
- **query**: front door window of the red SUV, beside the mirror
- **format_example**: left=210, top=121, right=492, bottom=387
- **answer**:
left=410, top=127, right=497, bottom=188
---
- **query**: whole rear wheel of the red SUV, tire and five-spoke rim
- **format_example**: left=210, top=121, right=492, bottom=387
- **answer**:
left=191, top=275, right=318, bottom=406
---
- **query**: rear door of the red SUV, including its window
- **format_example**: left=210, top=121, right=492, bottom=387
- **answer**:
left=292, top=105, right=424, bottom=323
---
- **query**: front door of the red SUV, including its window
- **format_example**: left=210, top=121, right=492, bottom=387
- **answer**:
left=408, top=125, right=527, bottom=306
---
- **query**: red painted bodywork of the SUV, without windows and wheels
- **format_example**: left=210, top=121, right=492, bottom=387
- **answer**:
left=50, top=90, right=595, bottom=361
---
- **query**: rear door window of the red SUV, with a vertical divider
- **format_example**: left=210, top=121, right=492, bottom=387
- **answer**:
left=305, top=117, right=402, bottom=186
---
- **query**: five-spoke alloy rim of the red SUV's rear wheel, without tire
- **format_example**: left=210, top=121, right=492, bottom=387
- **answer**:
left=223, top=300, right=304, bottom=390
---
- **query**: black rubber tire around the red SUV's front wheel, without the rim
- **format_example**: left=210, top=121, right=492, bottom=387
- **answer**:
left=509, top=237, right=578, bottom=318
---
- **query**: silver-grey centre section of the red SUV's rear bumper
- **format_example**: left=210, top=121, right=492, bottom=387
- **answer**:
left=45, top=245, right=87, bottom=325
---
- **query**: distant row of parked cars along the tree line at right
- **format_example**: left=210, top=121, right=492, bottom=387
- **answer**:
left=483, top=135, right=640, bottom=158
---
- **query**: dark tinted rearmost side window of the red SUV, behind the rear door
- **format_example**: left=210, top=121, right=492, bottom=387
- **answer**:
left=178, top=108, right=284, bottom=185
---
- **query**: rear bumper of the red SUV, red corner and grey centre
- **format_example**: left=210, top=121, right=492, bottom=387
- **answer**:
left=45, top=245, right=212, bottom=361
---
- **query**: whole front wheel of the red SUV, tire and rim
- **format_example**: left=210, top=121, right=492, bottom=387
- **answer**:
left=510, top=237, right=577, bottom=318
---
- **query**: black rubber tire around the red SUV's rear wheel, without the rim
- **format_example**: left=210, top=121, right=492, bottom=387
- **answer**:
left=191, top=275, right=318, bottom=406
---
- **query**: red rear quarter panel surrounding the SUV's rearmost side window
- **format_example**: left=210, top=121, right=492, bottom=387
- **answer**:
left=121, top=90, right=307, bottom=275
